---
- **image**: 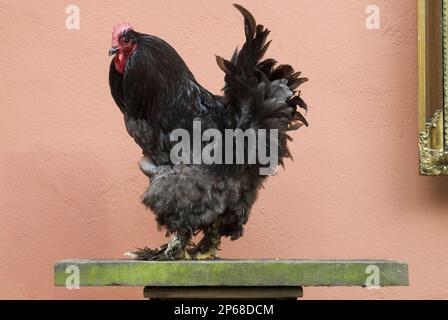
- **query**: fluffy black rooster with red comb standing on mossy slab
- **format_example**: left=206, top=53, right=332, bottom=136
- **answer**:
left=109, top=5, right=308, bottom=260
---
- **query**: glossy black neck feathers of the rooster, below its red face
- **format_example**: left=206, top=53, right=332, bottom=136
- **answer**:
left=110, top=30, right=208, bottom=120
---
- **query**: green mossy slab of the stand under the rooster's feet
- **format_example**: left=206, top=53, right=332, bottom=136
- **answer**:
left=54, top=260, right=409, bottom=286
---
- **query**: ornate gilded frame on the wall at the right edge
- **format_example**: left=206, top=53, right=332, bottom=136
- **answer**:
left=418, top=0, right=448, bottom=176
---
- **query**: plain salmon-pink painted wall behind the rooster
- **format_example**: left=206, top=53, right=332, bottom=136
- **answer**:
left=0, top=0, right=448, bottom=299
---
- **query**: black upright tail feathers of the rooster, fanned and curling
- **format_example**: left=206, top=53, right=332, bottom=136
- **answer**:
left=216, top=4, right=308, bottom=171
